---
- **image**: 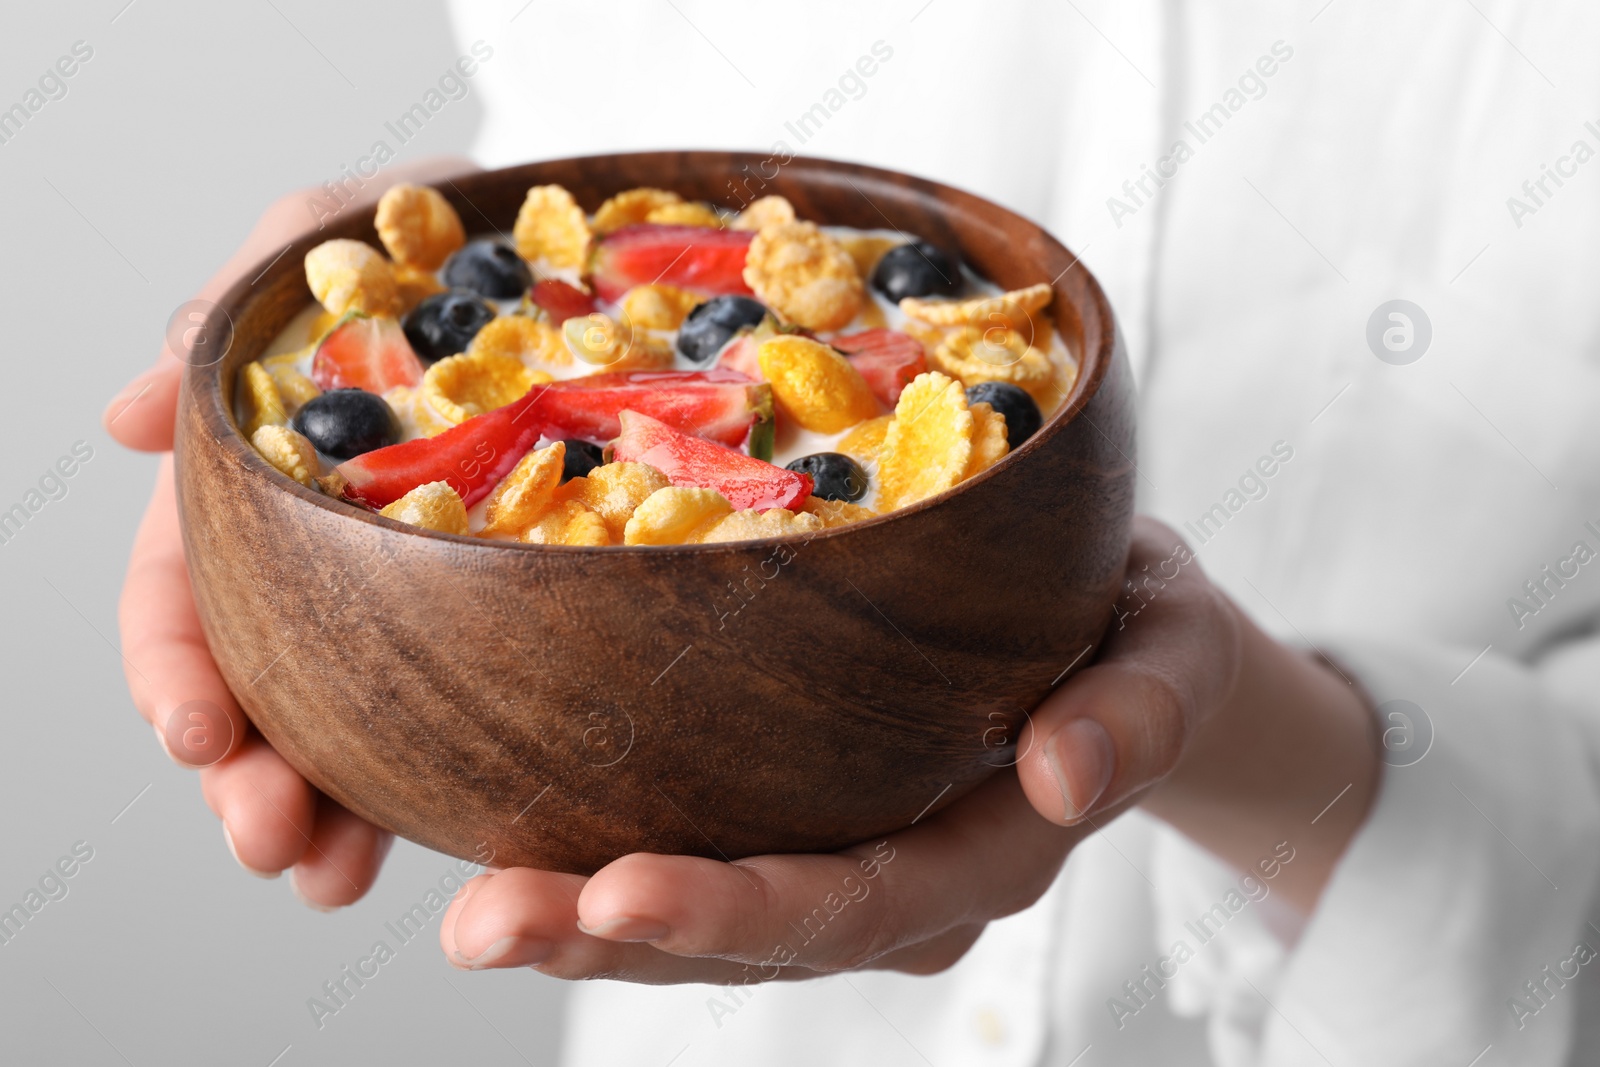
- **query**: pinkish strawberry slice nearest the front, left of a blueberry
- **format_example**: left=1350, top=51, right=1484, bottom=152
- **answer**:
left=611, top=411, right=811, bottom=510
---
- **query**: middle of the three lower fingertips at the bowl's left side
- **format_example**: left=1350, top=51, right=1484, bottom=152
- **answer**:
left=200, top=734, right=317, bottom=878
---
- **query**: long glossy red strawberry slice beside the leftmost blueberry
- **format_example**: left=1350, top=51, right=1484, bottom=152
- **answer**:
left=334, top=386, right=546, bottom=507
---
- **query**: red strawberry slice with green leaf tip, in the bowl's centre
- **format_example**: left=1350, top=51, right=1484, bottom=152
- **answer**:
left=541, top=368, right=773, bottom=459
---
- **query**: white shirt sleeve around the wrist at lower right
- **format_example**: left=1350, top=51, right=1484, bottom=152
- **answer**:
left=1155, top=640, right=1600, bottom=1067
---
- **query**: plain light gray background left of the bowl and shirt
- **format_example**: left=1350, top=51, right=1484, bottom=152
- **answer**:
left=0, top=0, right=562, bottom=1067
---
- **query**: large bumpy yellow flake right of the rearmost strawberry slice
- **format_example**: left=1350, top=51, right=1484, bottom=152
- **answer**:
left=744, top=222, right=866, bottom=330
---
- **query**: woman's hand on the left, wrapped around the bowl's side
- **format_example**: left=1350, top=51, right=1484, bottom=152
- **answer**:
left=104, top=158, right=472, bottom=909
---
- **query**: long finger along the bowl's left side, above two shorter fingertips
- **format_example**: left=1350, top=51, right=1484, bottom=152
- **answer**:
left=118, top=456, right=248, bottom=766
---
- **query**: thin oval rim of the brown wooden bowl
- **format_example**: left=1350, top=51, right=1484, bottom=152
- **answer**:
left=179, top=150, right=1118, bottom=557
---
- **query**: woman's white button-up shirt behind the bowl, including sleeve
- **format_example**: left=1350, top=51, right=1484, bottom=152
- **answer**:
left=454, top=0, right=1600, bottom=1067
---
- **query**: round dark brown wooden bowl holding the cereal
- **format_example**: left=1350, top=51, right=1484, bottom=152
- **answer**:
left=176, top=152, right=1134, bottom=872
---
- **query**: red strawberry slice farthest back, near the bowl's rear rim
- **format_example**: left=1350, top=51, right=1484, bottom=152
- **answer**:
left=590, top=222, right=755, bottom=304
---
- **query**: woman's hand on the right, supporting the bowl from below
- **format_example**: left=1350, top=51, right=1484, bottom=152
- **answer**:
left=440, top=520, right=1376, bottom=982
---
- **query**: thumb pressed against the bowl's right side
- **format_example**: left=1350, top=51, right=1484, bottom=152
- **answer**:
left=1018, top=520, right=1240, bottom=825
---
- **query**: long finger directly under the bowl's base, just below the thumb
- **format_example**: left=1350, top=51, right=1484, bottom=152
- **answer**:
left=578, top=773, right=1082, bottom=971
